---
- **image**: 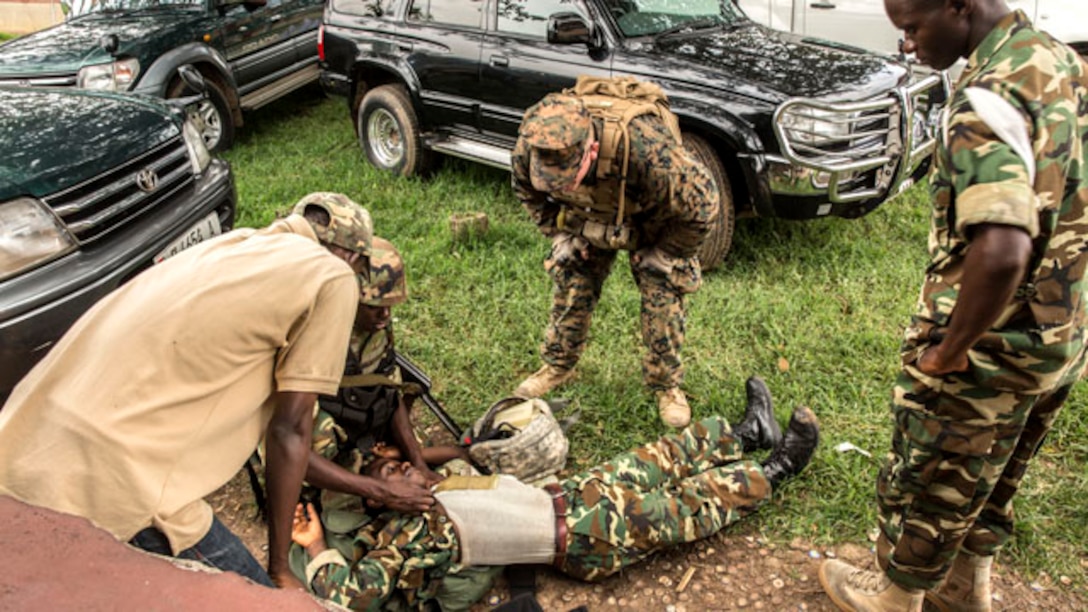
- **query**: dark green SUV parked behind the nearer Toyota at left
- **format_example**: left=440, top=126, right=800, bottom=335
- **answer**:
left=0, top=0, right=322, bottom=151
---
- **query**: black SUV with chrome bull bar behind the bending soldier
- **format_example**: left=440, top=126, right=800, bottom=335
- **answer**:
left=321, top=0, right=945, bottom=268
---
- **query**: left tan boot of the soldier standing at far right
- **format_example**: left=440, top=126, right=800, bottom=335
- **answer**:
left=819, top=559, right=926, bottom=612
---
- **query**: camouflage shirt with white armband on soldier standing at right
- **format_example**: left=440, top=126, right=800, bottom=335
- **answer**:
left=904, top=11, right=1088, bottom=393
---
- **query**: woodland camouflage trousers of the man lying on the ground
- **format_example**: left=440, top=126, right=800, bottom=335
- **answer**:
left=560, top=417, right=770, bottom=580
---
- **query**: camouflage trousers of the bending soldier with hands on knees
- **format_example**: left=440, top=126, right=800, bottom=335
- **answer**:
left=541, top=245, right=689, bottom=390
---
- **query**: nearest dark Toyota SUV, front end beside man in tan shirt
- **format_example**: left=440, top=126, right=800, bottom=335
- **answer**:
left=0, top=81, right=235, bottom=405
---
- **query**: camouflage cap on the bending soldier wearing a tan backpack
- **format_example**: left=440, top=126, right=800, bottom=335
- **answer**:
left=518, top=94, right=593, bottom=193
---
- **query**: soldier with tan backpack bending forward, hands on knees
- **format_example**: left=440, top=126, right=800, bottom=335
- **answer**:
left=511, top=78, right=718, bottom=428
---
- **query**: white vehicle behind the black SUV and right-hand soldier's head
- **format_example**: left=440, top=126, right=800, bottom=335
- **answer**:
left=734, top=0, right=1088, bottom=57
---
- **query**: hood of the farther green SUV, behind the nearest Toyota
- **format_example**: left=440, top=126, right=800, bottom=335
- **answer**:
left=0, top=10, right=203, bottom=76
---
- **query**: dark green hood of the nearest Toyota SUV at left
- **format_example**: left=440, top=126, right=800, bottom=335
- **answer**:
left=0, top=87, right=181, bottom=201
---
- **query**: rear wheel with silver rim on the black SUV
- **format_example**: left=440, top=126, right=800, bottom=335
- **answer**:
left=357, top=85, right=433, bottom=176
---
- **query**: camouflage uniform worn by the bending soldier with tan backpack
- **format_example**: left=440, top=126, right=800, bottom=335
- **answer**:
left=511, top=110, right=718, bottom=390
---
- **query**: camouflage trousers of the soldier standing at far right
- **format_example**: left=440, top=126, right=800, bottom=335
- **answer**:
left=877, top=366, right=1072, bottom=589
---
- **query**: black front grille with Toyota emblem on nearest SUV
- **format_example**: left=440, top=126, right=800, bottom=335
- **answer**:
left=46, top=137, right=193, bottom=244
